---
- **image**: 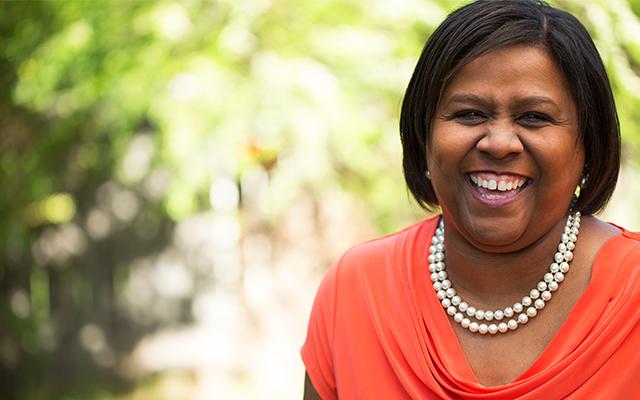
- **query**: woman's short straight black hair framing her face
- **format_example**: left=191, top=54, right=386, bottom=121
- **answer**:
left=400, top=0, right=620, bottom=214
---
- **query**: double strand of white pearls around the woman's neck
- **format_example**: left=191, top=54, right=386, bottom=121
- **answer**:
left=429, top=212, right=580, bottom=335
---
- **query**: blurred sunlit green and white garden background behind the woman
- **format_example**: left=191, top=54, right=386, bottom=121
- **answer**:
left=0, top=0, right=640, bottom=400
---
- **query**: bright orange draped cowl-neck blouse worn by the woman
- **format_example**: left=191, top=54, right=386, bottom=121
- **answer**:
left=301, top=217, right=640, bottom=400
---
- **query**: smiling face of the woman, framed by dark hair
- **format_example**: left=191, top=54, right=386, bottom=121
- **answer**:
left=427, top=45, right=584, bottom=252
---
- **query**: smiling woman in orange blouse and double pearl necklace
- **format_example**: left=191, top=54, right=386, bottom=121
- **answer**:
left=302, top=0, right=640, bottom=399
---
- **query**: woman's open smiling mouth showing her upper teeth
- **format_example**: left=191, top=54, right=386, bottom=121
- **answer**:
left=466, top=172, right=531, bottom=207
